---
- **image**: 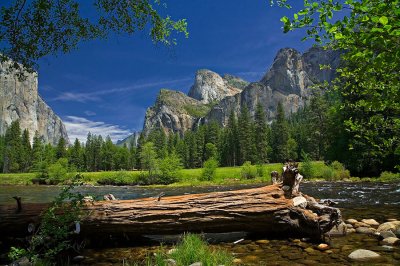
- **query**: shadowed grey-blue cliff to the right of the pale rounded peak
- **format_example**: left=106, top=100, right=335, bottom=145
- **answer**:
left=204, top=47, right=340, bottom=126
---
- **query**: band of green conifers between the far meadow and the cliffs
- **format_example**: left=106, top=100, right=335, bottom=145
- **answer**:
left=0, top=91, right=399, bottom=176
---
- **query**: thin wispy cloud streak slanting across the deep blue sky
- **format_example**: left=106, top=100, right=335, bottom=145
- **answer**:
left=51, top=78, right=192, bottom=103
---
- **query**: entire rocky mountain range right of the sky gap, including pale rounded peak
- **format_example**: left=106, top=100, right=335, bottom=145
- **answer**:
left=144, top=48, right=340, bottom=136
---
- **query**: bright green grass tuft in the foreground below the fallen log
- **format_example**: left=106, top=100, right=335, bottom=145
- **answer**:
left=154, top=233, right=233, bottom=266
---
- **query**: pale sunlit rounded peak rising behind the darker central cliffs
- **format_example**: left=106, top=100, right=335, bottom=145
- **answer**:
left=188, top=69, right=248, bottom=104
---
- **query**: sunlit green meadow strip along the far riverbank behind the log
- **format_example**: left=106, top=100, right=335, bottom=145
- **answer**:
left=0, top=161, right=400, bottom=186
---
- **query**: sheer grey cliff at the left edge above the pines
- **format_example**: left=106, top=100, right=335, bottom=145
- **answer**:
left=0, top=62, right=68, bottom=144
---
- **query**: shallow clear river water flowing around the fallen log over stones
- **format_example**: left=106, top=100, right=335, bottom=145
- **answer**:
left=0, top=182, right=400, bottom=265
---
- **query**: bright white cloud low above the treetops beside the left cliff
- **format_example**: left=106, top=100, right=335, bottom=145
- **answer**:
left=64, top=116, right=132, bottom=142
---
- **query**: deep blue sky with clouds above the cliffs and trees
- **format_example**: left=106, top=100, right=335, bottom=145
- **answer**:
left=39, top=0, right=312, bottom=141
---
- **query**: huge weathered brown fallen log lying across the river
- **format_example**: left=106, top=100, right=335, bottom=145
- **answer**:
left=0, top=184, right=340, bottom=238
